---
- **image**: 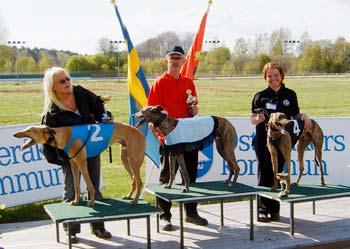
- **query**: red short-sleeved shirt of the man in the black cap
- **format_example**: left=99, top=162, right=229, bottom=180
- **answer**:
left=148, top=73, right=197, bottom=118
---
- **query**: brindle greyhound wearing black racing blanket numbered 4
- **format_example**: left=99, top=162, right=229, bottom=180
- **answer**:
left=267, top=112, right=325, bottom=197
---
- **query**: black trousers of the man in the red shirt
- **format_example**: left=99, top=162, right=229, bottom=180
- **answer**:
left=156, top=150, right=198, bottom=221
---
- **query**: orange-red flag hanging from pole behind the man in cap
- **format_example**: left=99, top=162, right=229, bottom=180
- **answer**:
left=181, top=0, right=212, bottom=80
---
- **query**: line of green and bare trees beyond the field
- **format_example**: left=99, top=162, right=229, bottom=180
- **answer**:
left=0, top=28, right=350, bottom=76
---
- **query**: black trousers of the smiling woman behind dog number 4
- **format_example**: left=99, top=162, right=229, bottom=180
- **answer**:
left=253, top=131, right=285, bottom=214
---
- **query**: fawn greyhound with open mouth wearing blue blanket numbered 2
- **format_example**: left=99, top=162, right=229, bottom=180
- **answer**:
left=13, top=122, right=146, bottom=207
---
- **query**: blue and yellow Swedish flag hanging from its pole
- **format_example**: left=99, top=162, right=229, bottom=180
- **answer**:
left=112, top=1, right=160, bottom=167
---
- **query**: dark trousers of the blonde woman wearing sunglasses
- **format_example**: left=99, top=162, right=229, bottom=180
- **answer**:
left=62, top=156, right=105, bottom=234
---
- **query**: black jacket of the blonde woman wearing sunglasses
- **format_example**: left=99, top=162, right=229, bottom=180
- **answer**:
left=41, top=86, right=104, bottom=165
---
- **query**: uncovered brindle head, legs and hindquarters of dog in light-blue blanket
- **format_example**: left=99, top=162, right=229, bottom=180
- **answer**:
left=135, top=106, right=240, bottom=192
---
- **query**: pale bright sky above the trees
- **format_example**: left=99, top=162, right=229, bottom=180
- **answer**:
left=0, top=0, right=350, bottom=54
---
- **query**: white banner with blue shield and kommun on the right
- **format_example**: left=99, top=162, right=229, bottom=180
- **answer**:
left=146, top=118, right=350, bottom=185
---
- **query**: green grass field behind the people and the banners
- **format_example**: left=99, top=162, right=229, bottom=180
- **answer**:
left=0, top=78, right=350, bottom=223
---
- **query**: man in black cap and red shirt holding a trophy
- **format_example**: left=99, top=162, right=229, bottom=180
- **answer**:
left=148, top=46, right=208, bottom=231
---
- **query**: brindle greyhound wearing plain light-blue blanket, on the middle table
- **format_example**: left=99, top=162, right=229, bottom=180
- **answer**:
left=135, top=105, right=240, bottom=192
